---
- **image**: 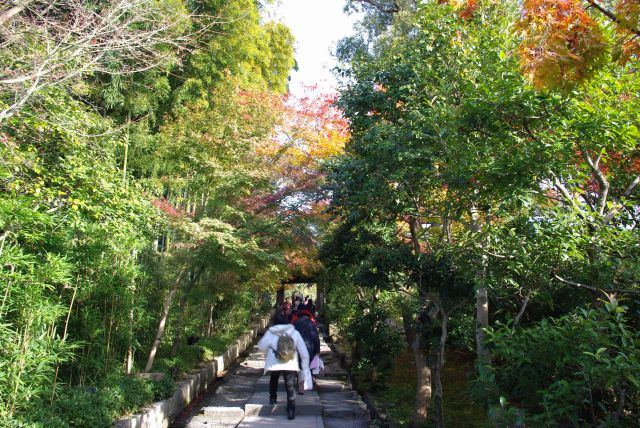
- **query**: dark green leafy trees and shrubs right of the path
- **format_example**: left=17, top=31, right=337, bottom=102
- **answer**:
left=321, top=1, right=640, bottom=426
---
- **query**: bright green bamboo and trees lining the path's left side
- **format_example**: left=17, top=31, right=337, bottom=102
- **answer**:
left=0, top=0, right=294, bottom=427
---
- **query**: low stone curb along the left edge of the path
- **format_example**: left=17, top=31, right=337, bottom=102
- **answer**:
left=113, top=313, right=272, bottom=428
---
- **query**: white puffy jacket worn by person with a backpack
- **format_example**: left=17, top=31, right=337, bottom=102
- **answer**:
left=258, top=324, right=309, bottom=379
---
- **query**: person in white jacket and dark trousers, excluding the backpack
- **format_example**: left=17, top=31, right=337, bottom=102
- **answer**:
left=258, top=312, right=309, bottom=419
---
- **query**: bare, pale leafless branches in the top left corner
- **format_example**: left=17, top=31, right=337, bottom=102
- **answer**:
left=0, top=0, right=205, bottom=123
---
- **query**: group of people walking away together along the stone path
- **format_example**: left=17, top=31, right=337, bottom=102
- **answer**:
left=258, top=293, right=323, bottom=419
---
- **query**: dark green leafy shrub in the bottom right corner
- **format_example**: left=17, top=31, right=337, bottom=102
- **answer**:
left=474, top=301, right=640, bottom=427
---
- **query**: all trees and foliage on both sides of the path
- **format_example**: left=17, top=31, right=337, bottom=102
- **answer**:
left=0, top=0, right=640, bottom=427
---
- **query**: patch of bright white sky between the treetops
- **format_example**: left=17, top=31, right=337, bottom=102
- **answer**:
left=266, top=0, right=357, bottom=96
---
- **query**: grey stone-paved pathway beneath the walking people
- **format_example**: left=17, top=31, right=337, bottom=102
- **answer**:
left=180, top=326, right=370, bottom=428
